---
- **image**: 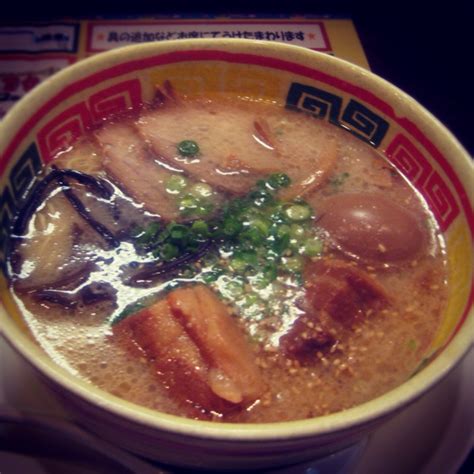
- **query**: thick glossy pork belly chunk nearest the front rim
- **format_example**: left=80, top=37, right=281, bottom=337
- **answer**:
left=114, top=285, right=265, bottom=414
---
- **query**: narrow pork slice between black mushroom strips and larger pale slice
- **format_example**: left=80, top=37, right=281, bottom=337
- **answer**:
left=95, top=122, right=179, bottom=220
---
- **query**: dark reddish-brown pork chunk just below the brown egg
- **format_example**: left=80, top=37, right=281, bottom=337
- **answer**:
left=280, top=258, right=391, bottom=359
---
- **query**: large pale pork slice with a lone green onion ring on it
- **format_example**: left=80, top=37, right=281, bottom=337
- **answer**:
left=136, top=101, right=337, bottom=199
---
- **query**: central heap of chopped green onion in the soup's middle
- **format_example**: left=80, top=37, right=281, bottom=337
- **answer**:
left=130, top=173, right=322, bottom=318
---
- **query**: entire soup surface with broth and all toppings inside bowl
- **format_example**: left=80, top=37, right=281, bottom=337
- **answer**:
left=10, top=89, right=447, bottom=422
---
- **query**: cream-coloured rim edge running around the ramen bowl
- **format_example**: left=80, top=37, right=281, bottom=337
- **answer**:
left=0, top=39, right=474, bottom=442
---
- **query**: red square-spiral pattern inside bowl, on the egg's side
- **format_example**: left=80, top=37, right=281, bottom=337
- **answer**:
left=385, top=133, right=459, bottom=231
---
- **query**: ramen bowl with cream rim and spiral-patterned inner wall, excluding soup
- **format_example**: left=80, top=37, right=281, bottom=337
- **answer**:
left=0, top=40, right=474, bottom=470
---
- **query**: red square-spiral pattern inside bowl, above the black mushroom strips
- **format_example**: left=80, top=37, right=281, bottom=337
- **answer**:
left=37, top=79, right=142, bottom=163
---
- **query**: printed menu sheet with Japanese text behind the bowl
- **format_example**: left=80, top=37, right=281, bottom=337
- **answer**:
left=0, top=17, right=369, bottom=119
